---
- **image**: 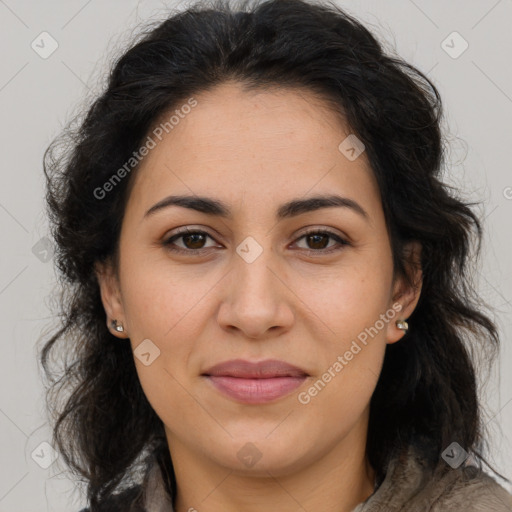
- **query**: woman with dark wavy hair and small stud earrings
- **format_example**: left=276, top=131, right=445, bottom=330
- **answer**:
left=41, top=0, right=512, bottom=512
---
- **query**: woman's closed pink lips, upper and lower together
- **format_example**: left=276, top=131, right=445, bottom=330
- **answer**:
left=203, top=359, right=308, bottom=404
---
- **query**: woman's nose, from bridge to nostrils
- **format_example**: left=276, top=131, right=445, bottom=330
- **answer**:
left=217, top=243, right=295, bottom=339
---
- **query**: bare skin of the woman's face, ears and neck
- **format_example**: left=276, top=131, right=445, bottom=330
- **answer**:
left=97, top=83, right=421, bottom=512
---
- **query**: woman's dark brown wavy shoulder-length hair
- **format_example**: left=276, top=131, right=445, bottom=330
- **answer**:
left=40, top=0, right=499, bottom=511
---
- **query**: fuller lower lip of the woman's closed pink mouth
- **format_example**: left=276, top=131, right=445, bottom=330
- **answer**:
left=206, top=375, right=306, bottom=404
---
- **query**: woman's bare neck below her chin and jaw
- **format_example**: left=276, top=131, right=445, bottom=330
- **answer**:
left=168, top=412, right=375, bottom=512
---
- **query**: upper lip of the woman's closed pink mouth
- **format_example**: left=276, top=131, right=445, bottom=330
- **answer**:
left=203, top=359, right=308, bottom=379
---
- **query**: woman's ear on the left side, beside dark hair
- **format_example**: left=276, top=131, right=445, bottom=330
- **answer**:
left=94, top=260, right=128, bottom=338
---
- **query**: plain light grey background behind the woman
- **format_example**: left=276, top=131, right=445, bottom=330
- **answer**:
left=0, top=0, right=512, bottom=512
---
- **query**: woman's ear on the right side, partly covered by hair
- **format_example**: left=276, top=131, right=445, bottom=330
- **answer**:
left=387, top=241, right=423, bottom=343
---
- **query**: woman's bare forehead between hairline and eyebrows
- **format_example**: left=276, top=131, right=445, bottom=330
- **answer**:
left=124, top=83, right=379, bottom=221
